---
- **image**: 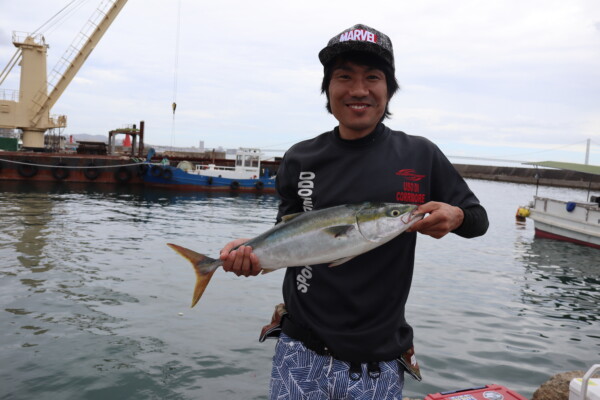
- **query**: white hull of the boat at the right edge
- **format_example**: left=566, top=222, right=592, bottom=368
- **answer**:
left=529, top=196, right=600, bottom=248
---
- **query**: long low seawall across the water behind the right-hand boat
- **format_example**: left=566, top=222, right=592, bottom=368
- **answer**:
left=453, top=164, right=600, bottom=190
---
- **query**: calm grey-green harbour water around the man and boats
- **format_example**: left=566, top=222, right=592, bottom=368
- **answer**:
left=0, top=180, right=600, bottom=399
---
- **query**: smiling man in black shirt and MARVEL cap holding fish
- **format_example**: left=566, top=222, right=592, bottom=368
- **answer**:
left=221, top=25, right=488, bottom=400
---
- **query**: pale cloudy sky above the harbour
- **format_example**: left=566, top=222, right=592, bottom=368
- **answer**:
left=0, top=0, right=600, bottom=165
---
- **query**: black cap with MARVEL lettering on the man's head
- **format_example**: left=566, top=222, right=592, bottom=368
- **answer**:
left=319, top=24, right=394, bottom=68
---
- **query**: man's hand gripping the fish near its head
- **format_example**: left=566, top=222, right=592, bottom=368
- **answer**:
left=407, top=201, right=465, bottom=239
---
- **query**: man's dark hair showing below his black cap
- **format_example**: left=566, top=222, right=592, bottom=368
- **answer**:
left=321, top=51, right=400, bottom=122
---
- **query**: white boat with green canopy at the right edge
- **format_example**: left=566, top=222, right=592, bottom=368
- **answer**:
left=517, top=161, right=600, bottom=249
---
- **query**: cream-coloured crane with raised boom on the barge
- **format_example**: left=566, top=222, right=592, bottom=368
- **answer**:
left=0, top=0, right=127, bottom=150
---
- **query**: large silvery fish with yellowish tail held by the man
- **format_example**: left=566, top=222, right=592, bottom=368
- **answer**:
left=167, top=202, right=424, bottom=307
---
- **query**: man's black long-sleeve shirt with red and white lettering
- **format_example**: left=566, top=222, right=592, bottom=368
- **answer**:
left=277, top=124, right=488, bottom=362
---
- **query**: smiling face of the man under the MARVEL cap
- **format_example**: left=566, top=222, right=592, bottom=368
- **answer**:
left=329, top=62, right=388, bottom=139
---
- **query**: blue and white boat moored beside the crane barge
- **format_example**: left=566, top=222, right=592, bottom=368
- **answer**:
left=143, top=148, right=275, bottom=193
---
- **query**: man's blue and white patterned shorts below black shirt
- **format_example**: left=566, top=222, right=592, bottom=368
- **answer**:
left=269, top=333, right=404, bottom=400
